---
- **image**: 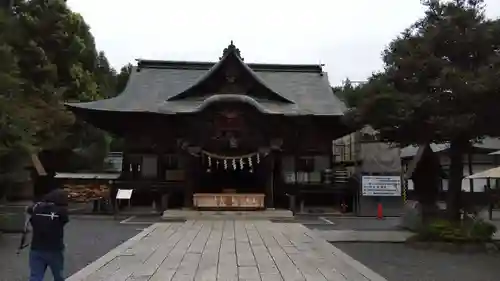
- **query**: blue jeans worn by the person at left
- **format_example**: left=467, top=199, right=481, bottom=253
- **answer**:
left=30, top=250, right=64, bottom=281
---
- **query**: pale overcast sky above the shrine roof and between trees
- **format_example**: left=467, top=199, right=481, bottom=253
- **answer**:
left=68, top=0, right=500, bottom=85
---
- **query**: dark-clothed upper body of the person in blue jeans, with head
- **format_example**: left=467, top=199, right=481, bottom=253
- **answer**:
left=28, top=189, right=69, bottom=251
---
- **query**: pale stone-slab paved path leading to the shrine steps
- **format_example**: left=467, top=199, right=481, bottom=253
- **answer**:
left=66, top=221, right=386, bottom=281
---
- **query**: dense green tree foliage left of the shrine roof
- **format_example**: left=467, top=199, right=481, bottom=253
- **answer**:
left=0, top=0, right=130, bottom=193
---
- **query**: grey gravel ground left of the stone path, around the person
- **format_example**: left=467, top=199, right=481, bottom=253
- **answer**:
left=0, top=217, right=147, bottom=281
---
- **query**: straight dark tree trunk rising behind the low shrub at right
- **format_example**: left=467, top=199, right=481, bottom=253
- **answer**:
left=446, top=139, right=469, bottom=221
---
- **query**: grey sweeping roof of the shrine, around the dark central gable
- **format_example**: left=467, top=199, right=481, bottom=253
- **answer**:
left=68, top=60, right=346, bottom=116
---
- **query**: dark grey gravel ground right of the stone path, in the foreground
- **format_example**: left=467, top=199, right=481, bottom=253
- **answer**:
left=333, top=243, right=500, bottom=281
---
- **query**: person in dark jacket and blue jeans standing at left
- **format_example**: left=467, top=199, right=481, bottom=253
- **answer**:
left=28, top=189, right=68, bottom=281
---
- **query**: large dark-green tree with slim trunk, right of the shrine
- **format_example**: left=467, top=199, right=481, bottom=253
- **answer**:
left=351, top=0, right=500, bottom=219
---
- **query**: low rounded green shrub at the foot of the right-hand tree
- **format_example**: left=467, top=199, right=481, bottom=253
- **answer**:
left=413, top=220, right=497, bottom=243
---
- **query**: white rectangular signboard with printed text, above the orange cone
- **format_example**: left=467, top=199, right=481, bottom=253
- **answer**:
left=361, top=176, right=401, bottom=196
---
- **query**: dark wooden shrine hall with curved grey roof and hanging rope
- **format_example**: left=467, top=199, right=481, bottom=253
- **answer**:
left=67, top=42, right=349, bottom=210
